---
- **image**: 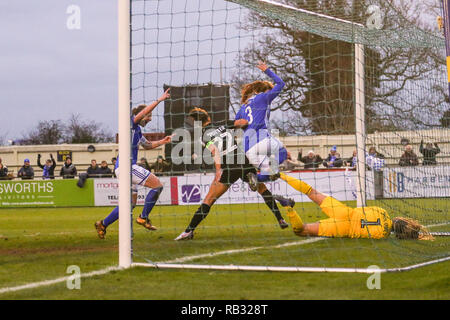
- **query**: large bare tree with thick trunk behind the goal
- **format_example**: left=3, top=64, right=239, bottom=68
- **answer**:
left=233, top=0, right=447, bottom=134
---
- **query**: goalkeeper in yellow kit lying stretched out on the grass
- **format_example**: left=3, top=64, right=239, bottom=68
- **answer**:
left=275, top=173, right=433, bottom=240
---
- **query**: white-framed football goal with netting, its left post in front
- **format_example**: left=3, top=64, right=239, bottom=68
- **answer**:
left=118, top=0, right=450, bottom=273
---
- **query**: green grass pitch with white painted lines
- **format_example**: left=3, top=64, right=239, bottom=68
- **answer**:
left=0, top=199, right=450, bottom=299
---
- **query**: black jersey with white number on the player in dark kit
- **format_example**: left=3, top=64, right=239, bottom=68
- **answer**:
left=202, top=121, right=249, bottom=168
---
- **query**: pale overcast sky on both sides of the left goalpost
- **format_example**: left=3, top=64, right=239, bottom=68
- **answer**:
left=0, top=0, right=250, bottom=139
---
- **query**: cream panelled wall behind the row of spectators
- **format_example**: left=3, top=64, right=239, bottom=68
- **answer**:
left=0, top=128, right=450, bottom=176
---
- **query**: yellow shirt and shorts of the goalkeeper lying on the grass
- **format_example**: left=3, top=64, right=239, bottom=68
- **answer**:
left=318, top=197, right=392, bottom=239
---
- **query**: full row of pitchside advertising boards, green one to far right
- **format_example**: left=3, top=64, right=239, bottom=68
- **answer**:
left=0, top=166, right=450, bottom=208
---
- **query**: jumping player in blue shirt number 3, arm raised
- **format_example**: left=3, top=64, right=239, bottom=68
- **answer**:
left=235, top=61, right=287, bottom=191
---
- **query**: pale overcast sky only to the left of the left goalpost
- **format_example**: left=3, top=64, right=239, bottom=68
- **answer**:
left=0, top=0, right=117, bottom=138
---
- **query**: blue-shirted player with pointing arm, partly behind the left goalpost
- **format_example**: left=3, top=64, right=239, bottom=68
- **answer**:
left=95, top=89, right=172, bottom=239
